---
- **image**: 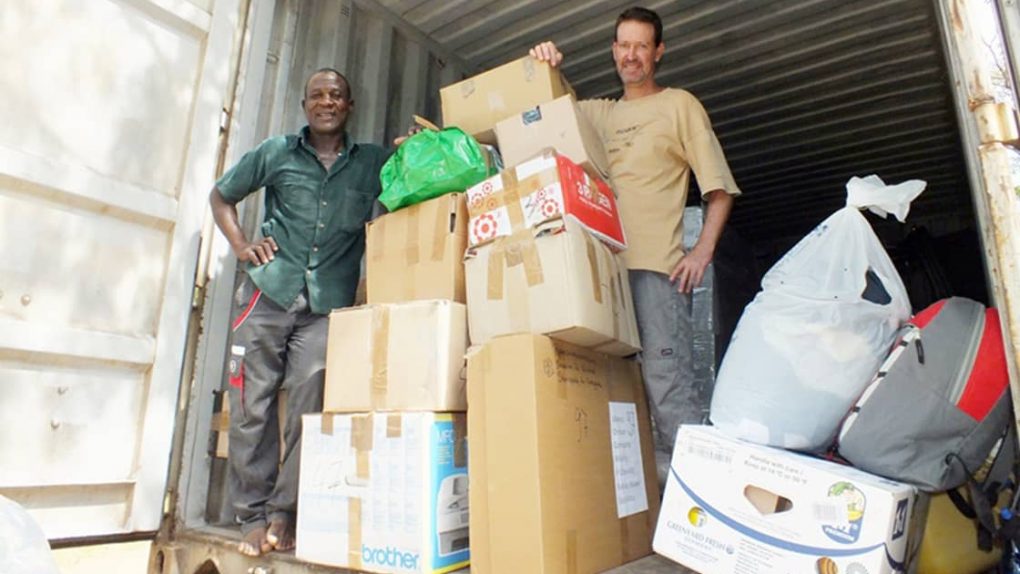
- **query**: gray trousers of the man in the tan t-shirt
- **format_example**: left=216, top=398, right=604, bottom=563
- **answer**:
left=629, top=269, right=708, bottom=453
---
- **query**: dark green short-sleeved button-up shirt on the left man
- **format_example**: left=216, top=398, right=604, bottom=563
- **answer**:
left=216, top=126, right=389, bottom=314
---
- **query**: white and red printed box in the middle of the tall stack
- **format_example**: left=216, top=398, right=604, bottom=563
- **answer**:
left=467, top=148, right=627, bottom=251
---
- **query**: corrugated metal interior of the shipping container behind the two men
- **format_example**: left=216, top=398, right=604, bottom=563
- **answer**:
left=169, top=0, right=1003, bottom=566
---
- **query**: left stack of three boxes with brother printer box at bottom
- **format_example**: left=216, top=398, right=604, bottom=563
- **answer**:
left=296, top=194, right=469, bottom=572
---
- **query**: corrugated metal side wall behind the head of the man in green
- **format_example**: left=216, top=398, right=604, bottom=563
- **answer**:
left=252, top=0, right=466, bottom=150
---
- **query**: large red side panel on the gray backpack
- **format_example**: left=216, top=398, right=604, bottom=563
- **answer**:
left=959, top=309, right=1009, bottom=421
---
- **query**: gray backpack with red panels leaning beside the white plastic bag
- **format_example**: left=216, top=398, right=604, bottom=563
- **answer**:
left=836, top=297, right=1017, bottom=545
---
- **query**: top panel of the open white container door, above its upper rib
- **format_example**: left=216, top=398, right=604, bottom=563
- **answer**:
left=0, top=0, right=202, bottom=203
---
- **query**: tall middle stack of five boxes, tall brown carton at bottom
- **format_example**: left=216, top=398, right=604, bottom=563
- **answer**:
left=441, top=58, right=658, bottom=574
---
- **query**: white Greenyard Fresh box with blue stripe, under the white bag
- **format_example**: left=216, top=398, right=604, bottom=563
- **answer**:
left=654, top=425, right=926, bottom=574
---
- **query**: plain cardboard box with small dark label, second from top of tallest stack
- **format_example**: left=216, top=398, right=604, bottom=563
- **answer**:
left=496, top=96, right=609, bottom=180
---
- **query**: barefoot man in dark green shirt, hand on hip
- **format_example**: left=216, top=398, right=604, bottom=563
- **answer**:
left=209, top=68, right=388, bottom=556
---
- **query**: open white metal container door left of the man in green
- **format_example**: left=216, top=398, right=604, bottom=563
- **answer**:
left=0, top=0, right=241, bottom=539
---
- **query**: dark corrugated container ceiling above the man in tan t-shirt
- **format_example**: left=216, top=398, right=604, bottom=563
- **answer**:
left=379, top=0, right=972, bottom=241
